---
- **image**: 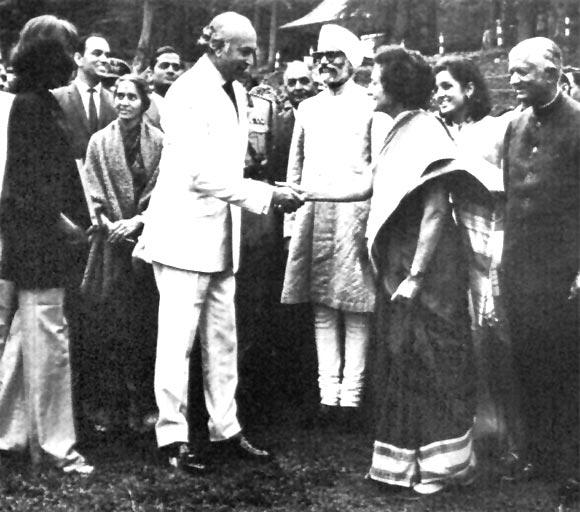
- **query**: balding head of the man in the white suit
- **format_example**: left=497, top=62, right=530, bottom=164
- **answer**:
left=202, top=12, right=257, bottom=81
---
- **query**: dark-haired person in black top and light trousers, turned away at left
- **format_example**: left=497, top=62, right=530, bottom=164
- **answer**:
left=0, top=15, right=93, bottom=474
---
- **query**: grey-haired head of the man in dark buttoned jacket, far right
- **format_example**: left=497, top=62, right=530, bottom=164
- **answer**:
left=509, top=37, right=562, bottom=107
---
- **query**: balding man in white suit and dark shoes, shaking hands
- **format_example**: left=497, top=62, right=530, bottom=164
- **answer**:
left=144, top=12, right=302, bottom=471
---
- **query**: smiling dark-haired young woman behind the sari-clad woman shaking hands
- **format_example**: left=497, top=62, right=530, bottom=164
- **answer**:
left=434, top=56, right=522, bottom=471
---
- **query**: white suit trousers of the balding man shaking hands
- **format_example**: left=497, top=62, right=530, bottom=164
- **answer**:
left=153, top=262, right=241, bottom=447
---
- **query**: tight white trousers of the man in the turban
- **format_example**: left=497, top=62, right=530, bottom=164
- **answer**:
left=314, top=305, right=369, bottom=407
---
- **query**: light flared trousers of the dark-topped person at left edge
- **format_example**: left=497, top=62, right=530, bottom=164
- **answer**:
left=0, top=288, right=84, bottom=469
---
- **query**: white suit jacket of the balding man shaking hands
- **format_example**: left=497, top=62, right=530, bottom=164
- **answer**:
left=143, top=55, right=272, bottom=272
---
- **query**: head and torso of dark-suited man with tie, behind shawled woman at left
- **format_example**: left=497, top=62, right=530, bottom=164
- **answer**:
left=53, top=34, right=117, bottom=161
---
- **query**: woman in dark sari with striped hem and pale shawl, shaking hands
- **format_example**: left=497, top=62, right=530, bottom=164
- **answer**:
left=288, top=46, right=489, bottom=494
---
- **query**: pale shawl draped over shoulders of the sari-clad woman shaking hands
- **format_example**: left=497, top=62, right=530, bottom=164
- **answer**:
left=366, top=110, right=492, bottom=314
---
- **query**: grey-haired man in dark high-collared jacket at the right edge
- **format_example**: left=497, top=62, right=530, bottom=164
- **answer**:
left=503, top=37, right=580, bottom=488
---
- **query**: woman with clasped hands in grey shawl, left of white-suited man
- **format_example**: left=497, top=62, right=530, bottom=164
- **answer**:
left=82, top=75, right=162, bottom=430
